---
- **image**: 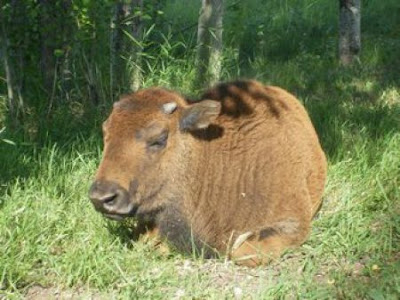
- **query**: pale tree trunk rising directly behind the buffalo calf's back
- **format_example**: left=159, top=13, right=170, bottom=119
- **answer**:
left=195, top=0, right=223, bottom=88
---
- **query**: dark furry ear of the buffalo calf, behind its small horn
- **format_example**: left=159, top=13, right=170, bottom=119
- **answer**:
left=179, top=100, right=221, bottom=131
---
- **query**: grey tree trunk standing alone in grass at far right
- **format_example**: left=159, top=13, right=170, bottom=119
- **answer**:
left=339, top=0, right=361, bottom=66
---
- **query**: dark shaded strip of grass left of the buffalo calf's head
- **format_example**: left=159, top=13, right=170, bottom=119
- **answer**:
left=0, top=107, right=105, bottom=190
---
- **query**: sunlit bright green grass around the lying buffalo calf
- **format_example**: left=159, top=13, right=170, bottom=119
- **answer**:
left=0, top=122, right=400, bottom=299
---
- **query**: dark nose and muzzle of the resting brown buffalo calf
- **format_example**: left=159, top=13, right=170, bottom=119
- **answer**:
left=89, top=180, right=133, bottom=215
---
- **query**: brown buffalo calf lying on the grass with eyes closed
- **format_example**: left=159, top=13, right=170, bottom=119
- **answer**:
left=90, top=81, right=326, bottom=266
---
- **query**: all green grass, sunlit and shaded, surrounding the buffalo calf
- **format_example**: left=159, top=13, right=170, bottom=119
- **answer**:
left=0, top=0, right=400, bottom=300
